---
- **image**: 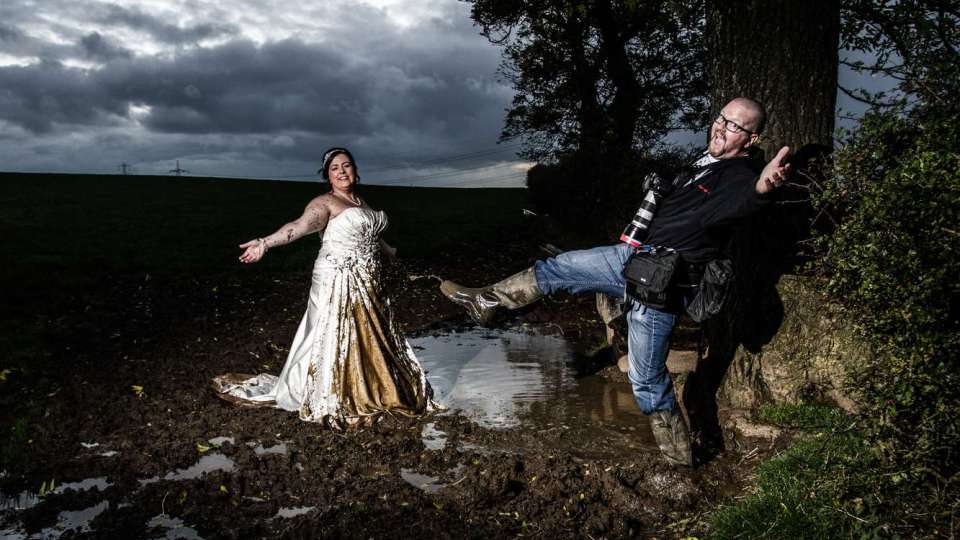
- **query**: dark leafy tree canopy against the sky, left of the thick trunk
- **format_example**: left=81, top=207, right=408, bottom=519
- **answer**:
left=469, top=0, right=707, bottom=162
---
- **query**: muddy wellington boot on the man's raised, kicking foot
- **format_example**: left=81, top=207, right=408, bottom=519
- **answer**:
left=440, top=266, right=543, bottom=326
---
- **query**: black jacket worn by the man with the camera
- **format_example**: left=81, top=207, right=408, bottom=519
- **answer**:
left=644, top=157, right=766, bottom=264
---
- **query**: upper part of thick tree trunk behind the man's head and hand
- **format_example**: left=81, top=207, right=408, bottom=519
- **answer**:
left=706, top=0, right=840, bottom=157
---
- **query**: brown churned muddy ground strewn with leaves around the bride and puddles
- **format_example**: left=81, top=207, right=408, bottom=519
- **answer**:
left=0, top=245, right=782, bottom=538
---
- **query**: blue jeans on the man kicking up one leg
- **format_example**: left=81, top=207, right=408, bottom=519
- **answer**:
left=534, top=244, right=677, bottom=414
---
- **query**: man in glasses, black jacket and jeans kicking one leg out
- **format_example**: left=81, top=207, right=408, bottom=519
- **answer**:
left=440, top=98, right=790, bottom=466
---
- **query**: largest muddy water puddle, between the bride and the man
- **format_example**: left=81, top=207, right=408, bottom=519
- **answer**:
left=410, top=329, right=656, bottom=456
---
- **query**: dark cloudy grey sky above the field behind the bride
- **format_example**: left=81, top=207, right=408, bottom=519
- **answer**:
left=0, top=0, right=884, bottom=187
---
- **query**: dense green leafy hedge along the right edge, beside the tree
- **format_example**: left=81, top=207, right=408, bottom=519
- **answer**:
left=816, top=105, right=960, bottom=527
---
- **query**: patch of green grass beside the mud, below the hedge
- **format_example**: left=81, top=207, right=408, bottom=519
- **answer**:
left=710, top=405, right=884, bottom=539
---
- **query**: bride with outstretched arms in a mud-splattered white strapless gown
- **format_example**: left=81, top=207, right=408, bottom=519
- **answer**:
left=213, top=148, right=437, bottom=427
